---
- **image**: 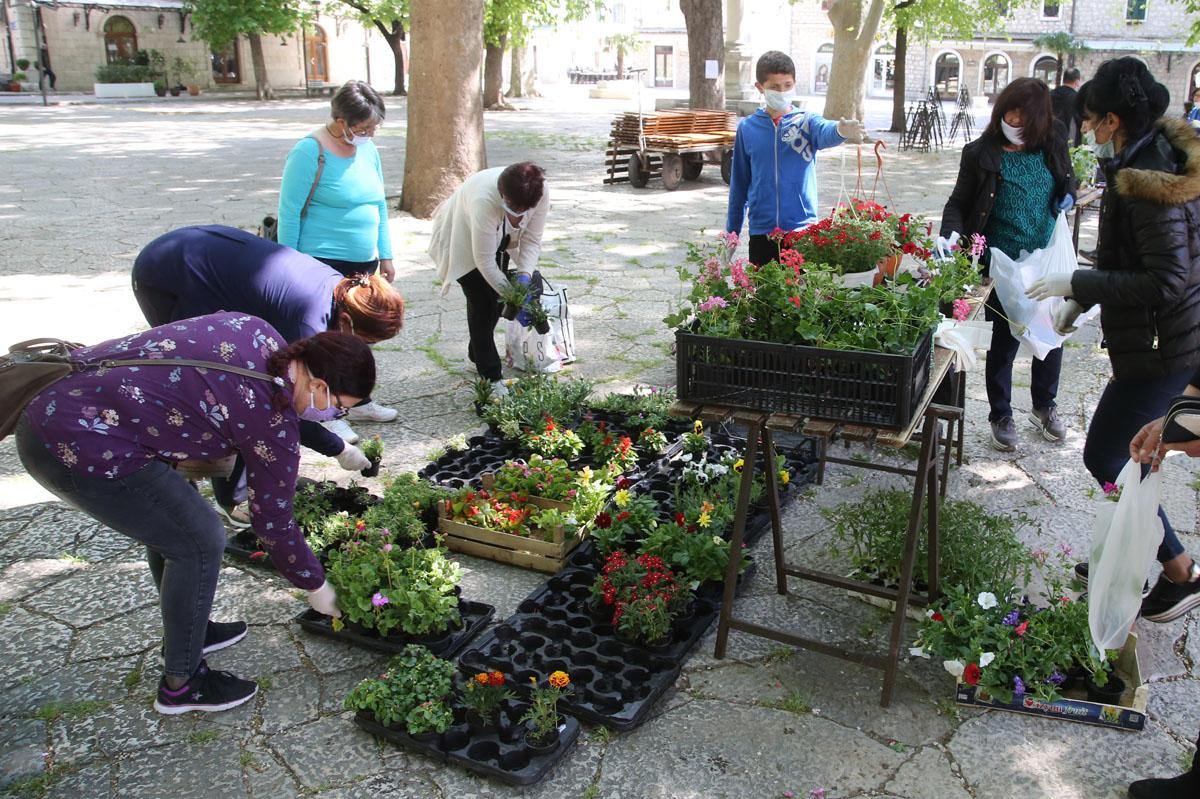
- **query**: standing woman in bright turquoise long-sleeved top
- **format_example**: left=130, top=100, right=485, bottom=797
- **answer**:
left=278, top=80, right=396, bottom=282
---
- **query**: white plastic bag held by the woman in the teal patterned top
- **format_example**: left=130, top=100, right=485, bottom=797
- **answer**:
left=990, top=211, right=1099, bottom=360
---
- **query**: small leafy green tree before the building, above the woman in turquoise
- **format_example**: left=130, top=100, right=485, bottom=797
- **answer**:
left=187, top=0, right=307, bottom=100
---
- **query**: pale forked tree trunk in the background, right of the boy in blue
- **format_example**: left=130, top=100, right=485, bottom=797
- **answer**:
left=824, top=0, right=883, bottom=120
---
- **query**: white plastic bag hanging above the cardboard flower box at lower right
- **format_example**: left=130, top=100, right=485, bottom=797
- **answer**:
left=1087, top=461, right=1163, bottom=651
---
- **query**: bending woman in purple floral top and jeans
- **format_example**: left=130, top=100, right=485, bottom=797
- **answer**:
left=17, top=313, right=376, bottom=714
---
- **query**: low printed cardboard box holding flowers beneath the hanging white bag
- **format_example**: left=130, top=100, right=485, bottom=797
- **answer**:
left=954, top=632, right=1150, bottom=732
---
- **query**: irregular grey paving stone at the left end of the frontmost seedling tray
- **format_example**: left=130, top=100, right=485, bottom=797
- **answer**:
left=271, top=713, right=383, bottom=788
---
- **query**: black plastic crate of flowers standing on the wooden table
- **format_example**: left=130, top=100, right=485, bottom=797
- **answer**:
left=676, top=330, right=934, bottom=427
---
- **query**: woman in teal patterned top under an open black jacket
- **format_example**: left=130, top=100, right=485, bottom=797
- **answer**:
left=941, top=78, right=1074, bottom=452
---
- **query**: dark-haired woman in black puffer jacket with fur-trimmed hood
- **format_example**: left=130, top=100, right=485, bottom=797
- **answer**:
left=1030, top=58, right=1200, bottom=621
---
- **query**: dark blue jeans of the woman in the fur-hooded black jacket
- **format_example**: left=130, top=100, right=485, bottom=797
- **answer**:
left=1084, top=370, right=1192, bottom=563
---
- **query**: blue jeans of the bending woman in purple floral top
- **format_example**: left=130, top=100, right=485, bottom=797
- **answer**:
left=17, top=416, right=226, bottom=678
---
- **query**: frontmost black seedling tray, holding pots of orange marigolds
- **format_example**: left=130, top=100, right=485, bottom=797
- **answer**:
left=354, top=701, right=580, bottom=785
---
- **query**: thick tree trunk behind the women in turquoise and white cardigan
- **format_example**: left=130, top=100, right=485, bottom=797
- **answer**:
left=400, top=0, right=486, bottom=218
